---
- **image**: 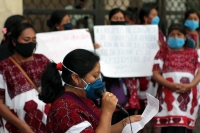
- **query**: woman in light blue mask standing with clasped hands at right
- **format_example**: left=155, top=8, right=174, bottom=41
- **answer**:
left=153, top=24, right=200, bottom=133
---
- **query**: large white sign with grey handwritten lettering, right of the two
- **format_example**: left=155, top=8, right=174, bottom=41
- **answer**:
left=94, top=25, right=159, bottom=77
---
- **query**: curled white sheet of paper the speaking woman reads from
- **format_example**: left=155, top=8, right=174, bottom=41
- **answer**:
left=122, top=93, right=159, bottom=133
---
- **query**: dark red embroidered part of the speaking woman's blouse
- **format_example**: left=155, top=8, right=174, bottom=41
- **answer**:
left=46, top=98, right=100, bottom=133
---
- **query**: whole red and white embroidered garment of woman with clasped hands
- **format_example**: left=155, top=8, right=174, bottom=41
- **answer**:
left=153, top=48, right=200, bottom=129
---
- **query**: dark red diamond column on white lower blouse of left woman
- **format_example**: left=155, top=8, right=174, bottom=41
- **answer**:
left=24, top=100, right=45, bottom=133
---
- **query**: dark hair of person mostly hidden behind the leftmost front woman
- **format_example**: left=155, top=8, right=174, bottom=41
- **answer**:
left=1, top=15, right=27, bottom=44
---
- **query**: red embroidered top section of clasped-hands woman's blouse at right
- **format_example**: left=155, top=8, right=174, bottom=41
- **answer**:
left=153, top=48, right=200, bottom=75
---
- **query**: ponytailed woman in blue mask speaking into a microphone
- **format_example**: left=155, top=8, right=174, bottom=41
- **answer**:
left=39, top=49, right=141, bottom=133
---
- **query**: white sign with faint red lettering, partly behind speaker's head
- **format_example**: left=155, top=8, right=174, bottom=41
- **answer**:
left=36, top=29, right=94, bottom=63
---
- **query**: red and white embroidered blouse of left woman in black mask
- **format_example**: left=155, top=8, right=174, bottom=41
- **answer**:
left=0, top=54, right=49, bottom=133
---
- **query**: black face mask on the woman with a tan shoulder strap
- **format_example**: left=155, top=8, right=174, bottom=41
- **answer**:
left=15, top=42, right=36, bottom=57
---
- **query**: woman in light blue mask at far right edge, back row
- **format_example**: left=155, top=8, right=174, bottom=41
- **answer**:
left=184, top=9, right=200, bottom=49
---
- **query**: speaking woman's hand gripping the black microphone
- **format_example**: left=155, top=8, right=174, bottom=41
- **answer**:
left=101, top=92, right=118, bottom=115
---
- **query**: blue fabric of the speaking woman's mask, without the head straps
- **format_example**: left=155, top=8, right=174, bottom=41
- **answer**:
left=83, top=78, right=104, bottom=100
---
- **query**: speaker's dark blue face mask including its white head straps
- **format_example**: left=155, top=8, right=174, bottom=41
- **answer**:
left=63, top=64, right=104, bottom=100
